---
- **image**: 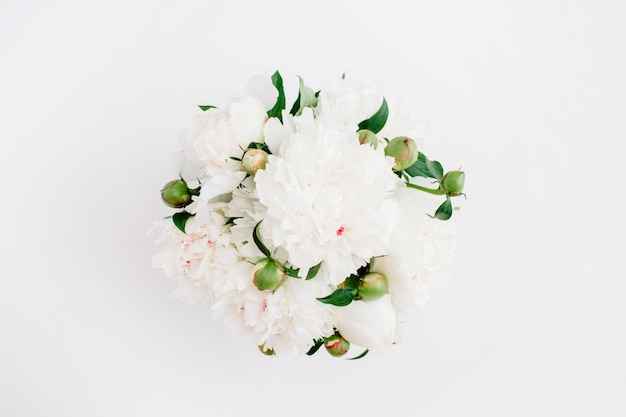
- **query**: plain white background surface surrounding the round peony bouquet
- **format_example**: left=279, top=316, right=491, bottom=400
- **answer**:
left=0, top=0, right=626, bottom=416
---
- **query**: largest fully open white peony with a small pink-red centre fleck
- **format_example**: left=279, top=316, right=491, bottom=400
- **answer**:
left=250, top=118, right=401, bottom=284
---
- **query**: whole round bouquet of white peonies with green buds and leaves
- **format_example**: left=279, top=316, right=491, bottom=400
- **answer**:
left=153, top=72, right=465, bottom=358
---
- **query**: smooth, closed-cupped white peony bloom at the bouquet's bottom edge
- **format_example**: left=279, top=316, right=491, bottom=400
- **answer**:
left=336, top=295, right=397, bottom=348
